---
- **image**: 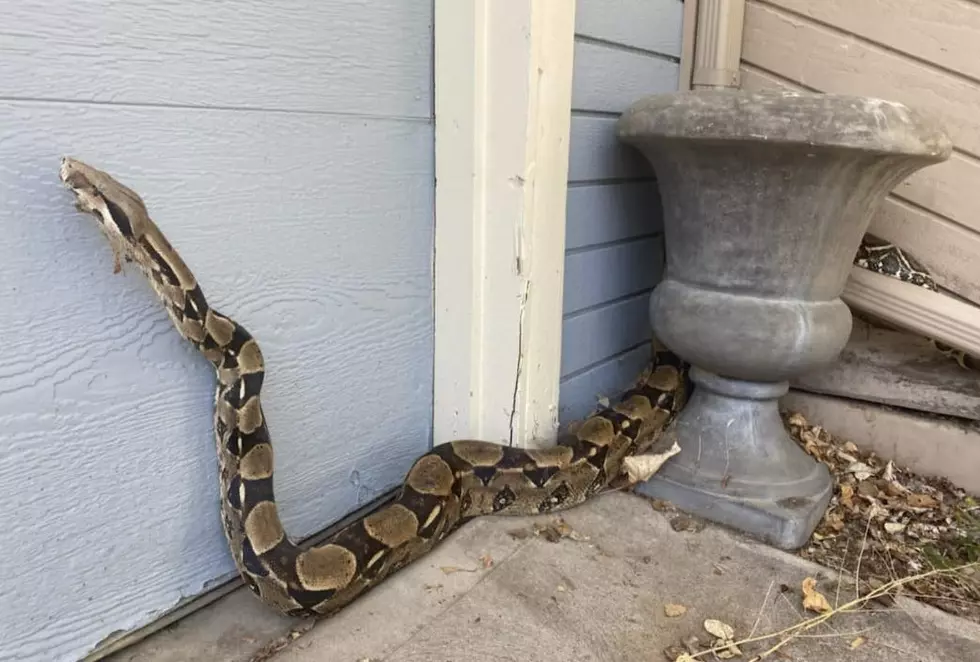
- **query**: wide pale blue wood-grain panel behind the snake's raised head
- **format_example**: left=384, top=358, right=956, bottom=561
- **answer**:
left=0, top=0, right=434, bottom=662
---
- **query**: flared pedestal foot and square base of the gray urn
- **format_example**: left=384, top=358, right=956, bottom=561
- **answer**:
left=636, top=367, right=833, bottom=549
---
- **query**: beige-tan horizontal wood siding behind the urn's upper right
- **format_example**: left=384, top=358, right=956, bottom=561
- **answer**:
left=742, top=0, right=980, bottom=304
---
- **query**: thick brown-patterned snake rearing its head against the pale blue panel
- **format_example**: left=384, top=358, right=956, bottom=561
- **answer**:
left=60, top=156, right=691, bottom=617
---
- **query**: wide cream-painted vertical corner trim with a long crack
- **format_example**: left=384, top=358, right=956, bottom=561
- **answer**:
left=433, top=0, right=575, bottom=447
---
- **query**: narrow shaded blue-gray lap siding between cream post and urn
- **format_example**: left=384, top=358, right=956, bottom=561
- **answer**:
left=559, top=0, right=683, bottom=425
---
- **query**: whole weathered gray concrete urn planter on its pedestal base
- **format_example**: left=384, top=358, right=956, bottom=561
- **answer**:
left=617, top=90, right=951, bottom=549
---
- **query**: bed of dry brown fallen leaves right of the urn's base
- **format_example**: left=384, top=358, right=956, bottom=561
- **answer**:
left=785, top=413, right=980, bottom=623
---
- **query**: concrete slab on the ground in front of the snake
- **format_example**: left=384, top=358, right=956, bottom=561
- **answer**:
left=111, top=494, right=980, bottom=662
